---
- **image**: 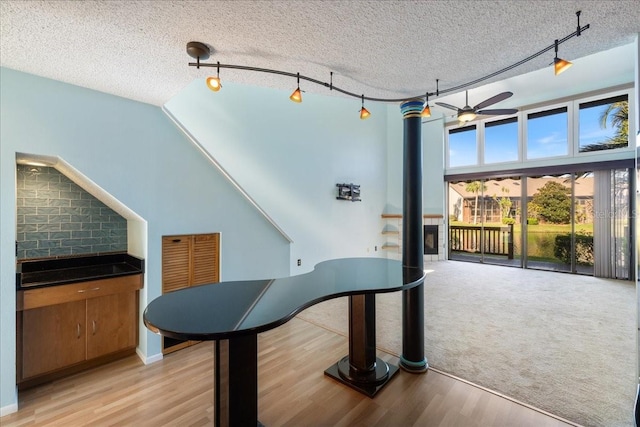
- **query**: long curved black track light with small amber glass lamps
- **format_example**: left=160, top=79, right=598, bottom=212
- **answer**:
left=187, top=11, right=589, bottom=121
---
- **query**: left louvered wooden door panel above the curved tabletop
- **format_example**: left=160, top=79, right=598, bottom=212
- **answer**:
left=162, top=236, right=192, bottom=293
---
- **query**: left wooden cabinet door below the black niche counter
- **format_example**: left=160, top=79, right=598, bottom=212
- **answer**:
left=22, top=300, right=86, bottom=378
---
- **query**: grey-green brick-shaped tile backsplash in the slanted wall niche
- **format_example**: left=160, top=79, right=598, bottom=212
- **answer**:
left=16, top=165, right=127, bottom=260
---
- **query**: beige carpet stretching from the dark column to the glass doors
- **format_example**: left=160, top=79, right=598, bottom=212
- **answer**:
left=298, top=261, right=637, bottom=427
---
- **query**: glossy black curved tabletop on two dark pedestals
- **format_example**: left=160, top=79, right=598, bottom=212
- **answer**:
left=144, top=258, right=425, bottom=340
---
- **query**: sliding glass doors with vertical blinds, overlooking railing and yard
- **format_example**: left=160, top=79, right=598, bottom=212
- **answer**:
left=448, top=169, right=633, bottom=279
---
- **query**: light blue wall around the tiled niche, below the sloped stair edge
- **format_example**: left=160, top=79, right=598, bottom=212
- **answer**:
left=0, top=68, right=290, bottom=408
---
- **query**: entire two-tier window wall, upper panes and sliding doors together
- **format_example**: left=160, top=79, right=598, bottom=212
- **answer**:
left=445, top=89, right=640, bottom=279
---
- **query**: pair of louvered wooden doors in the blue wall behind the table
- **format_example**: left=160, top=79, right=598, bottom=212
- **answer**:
left=162, top=233, right=220, bottom=354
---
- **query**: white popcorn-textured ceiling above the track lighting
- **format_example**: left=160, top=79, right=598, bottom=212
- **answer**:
left=0, top=0, right=640, bottom=105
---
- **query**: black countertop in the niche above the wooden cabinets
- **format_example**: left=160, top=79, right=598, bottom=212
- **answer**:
left=16, top=253, right=144, bottom=290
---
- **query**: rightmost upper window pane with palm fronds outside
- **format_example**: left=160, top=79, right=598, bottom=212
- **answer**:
left=578, top=95, right=629, bottom=153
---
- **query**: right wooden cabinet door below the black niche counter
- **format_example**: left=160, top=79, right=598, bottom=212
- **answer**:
left=87, top=292, right=138, bottom=359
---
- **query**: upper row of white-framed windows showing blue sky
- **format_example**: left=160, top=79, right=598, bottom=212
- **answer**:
left=446, top=89, right=636, bottom=167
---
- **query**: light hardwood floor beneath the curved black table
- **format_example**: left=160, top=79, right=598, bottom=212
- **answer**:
left=0, top=318, right=572, bottom=427
